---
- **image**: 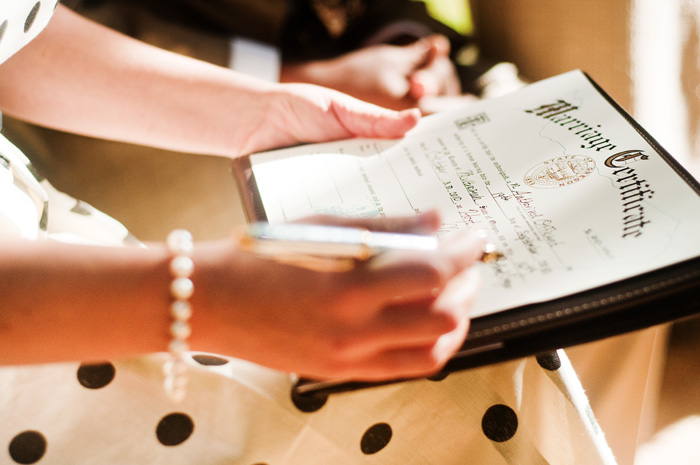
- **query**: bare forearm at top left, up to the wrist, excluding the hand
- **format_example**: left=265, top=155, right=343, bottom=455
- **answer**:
left=0, top=5, right=272, bottom=156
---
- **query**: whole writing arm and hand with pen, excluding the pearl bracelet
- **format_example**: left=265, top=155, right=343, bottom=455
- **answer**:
left=0, top=216, right=482, bottom=380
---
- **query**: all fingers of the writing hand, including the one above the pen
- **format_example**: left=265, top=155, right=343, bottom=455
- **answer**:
left=260, top=212, right=484, bottom=381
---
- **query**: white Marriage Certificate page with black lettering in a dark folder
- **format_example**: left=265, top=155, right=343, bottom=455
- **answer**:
left=250, top=71, right=700, bottom=317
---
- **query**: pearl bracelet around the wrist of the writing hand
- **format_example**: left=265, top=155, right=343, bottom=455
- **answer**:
left=163, top=229, right=194, bottom=402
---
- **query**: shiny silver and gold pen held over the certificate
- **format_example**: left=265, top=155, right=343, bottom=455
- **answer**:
left=240, top=223, right=503, bottom=271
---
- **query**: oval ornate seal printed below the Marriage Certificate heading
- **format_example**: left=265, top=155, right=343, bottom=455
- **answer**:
left=523, top=155, right=595, bottom=189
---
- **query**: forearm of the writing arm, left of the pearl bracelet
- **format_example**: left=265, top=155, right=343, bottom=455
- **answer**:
left=0, top=241, right=170, bottom=365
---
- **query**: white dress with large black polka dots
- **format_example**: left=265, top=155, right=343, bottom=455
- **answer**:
left=0, top=0, right=615, bottom=465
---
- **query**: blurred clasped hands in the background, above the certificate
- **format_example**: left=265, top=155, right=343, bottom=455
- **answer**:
left=282, top=35, right=460, bottom=110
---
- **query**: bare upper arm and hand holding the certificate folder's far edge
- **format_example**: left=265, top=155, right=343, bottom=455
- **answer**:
left=0, top=5, right=419, bottom=156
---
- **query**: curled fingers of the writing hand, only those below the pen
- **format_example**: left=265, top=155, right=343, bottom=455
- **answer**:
left=308, top=232, right=483, bottom=380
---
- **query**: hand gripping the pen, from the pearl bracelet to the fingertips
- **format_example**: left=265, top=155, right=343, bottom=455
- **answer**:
left=191, top=215, right=483, bottom=380
